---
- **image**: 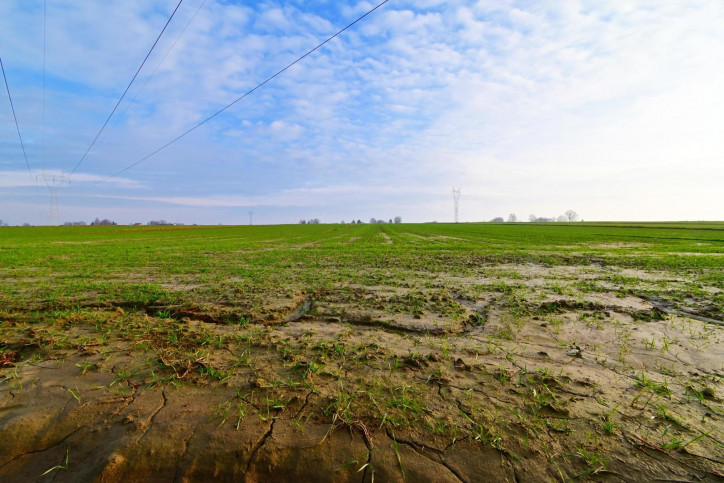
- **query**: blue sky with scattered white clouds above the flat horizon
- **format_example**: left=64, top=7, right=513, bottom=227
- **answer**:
left=0, top=0, right=724, bottom=224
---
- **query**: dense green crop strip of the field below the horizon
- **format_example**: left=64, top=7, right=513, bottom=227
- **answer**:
left=0, top=223, right=724, bottom=308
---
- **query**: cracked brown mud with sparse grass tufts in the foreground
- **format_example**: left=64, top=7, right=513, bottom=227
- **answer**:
left=0, top=262, right=724, bottom=482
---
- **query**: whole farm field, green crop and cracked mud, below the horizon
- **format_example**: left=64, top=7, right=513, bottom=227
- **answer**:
left=0, top=223, right=724, bottom=482
